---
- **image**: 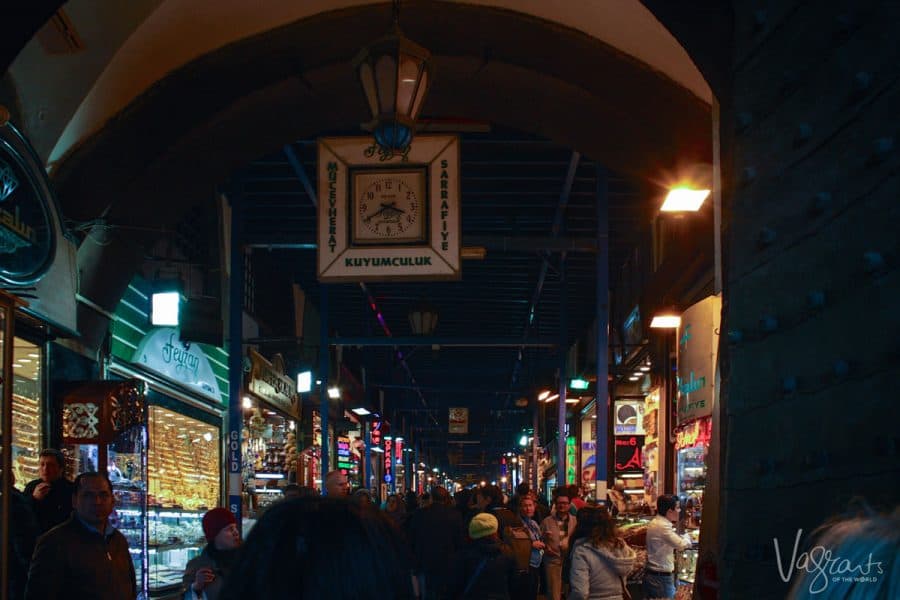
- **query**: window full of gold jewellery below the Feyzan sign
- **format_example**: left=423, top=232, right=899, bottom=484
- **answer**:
left=148, top=406, right=220, bottom=591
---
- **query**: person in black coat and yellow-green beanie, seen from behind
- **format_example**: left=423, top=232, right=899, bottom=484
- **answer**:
left=449, top=513, right=517, bottom=600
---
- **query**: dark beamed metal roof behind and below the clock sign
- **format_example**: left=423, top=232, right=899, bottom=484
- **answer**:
left=234, top=128, right=649, bottom=474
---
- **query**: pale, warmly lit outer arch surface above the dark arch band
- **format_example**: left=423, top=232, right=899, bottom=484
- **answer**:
left=37, top=0, right=711, bottom=163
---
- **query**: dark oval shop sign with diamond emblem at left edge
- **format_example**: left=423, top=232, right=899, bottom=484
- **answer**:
left=0, top=123, right=55, bottom=286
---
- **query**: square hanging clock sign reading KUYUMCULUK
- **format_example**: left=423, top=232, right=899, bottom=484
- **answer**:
left=318, top=136, right=462, bottom=282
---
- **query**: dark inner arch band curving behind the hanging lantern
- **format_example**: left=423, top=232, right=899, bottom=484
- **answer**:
left=42, top=2, right=711, bottom=231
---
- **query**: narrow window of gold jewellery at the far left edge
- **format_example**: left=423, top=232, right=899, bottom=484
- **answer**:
left=12, top=338, right=43, bottom=489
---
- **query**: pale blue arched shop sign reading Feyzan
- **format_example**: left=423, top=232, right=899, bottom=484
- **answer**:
left=131, top=327, right=222, bottom=404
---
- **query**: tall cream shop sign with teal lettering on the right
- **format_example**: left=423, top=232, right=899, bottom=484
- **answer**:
left=676, top=296, right=722, bottom=425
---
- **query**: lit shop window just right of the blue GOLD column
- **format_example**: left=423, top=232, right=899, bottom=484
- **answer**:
left=241, top=397, right=299, bottom=519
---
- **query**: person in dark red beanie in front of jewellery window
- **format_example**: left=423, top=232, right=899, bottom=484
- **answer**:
left=182, top=507, right=241, bottom=600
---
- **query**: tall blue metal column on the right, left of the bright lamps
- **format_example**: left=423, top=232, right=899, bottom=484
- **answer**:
left=594, top=164, right=609, bottom=503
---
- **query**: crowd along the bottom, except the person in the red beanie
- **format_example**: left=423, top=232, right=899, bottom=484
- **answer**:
left=8, top=450, right=900, bottom=600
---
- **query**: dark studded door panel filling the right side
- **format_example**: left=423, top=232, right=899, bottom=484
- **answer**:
left=719, top=0, right=900, bottom=599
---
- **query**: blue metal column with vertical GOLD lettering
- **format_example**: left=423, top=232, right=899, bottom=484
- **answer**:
left=228, top=184, right=244, bottom=529
